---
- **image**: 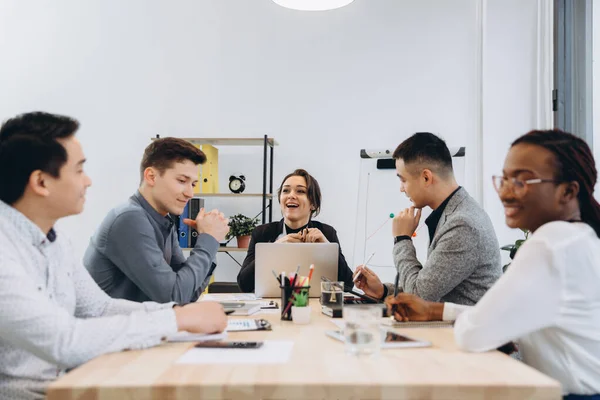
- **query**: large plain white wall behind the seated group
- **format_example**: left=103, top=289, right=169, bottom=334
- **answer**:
left=0, top=0, right=536, bottom=280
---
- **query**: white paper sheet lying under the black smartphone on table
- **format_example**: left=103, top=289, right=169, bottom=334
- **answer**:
left=176, top=340, right=294, bottom=364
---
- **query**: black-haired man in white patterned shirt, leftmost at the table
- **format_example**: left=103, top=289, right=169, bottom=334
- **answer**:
left=0, top=112, right=227, bottom=399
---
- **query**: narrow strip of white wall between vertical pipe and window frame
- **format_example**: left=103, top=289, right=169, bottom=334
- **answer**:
left=482, top=0, right=551, bottom=262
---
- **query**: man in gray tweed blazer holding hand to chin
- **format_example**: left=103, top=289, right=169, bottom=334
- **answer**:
left=355, top=132, right=502, bottom=305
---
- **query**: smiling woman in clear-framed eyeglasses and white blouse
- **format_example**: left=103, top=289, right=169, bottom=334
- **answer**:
left=386, top=130, right=600, bottom=400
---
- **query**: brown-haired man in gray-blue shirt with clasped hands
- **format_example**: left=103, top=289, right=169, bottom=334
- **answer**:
left=84, top=138, right=229, bottom=304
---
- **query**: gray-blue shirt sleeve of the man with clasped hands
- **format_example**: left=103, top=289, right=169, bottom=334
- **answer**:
left=106, top=211, right=219, bottom=303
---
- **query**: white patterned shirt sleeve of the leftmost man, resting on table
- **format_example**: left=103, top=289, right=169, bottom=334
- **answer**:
left=0, top=256, right=177, bottom=368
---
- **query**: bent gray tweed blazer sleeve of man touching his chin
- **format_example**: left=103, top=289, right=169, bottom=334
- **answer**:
left=388, top=223, right=477, bottom=301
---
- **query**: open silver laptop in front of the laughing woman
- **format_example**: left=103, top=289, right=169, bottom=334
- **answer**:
left=254, top=243, right=340, bottom=297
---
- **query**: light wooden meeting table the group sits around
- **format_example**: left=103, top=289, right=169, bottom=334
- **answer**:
left=48, top=301, right=561, bottom=400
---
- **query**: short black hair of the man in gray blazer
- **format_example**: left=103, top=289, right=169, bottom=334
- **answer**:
left=392, top=132, right=454, bottom=175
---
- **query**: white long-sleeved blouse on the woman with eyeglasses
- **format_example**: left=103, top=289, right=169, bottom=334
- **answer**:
left=444, top=221, right=600, bottom=394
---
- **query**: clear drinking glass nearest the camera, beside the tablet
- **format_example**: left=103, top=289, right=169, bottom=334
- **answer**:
left=344, top=305, right=381, bottom=356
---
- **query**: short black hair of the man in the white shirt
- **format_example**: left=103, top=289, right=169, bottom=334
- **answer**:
left=0, top=111, right=79, bottom=205
